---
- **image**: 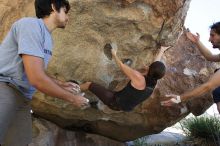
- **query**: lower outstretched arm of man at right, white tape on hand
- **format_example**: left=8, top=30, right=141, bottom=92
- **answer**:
left=161, top=71, right=220, bottom=106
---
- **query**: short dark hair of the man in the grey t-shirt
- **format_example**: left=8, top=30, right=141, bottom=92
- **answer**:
left=34, top=0, right=70, bottom=18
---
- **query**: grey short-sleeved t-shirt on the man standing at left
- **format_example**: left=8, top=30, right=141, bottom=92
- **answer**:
left=0, top=17, right=53, bottom=98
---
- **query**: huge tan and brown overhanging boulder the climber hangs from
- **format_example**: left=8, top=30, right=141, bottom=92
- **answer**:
left=0, top=0, right=216, bottom=141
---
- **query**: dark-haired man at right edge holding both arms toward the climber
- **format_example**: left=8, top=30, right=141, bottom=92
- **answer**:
left=161, top=22, right=220, bottom=114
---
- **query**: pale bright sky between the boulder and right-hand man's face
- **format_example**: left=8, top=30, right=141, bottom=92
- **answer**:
left=185, top=0, right=220, bottom=52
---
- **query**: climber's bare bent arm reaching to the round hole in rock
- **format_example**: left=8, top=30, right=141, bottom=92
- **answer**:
left=111, top=43, right=145, bottom=90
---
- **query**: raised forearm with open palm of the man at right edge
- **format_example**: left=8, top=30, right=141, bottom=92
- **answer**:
left=186, top=31, right=220, bottom=62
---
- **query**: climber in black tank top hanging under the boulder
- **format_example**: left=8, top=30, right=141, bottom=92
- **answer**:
left=80, top=43, right=170, bottom=111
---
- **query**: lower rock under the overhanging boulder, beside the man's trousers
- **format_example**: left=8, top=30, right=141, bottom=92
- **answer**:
left=29, top=118, right=125, bottom=146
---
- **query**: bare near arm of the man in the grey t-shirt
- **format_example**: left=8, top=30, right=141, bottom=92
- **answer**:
left=22, top=55, right=88, bottom=107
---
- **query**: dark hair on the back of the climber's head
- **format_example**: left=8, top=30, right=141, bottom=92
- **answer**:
left=145, top=61, right=166, bottom=87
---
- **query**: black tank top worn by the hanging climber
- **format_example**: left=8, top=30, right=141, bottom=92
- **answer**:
left=115, top=78, right=156, bottom=111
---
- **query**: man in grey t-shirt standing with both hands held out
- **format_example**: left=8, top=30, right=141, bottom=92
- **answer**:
left=0, top=0, right=88, bottom=146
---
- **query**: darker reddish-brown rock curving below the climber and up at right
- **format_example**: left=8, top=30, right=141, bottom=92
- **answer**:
left=33, top=32, right=217, bottom=141
